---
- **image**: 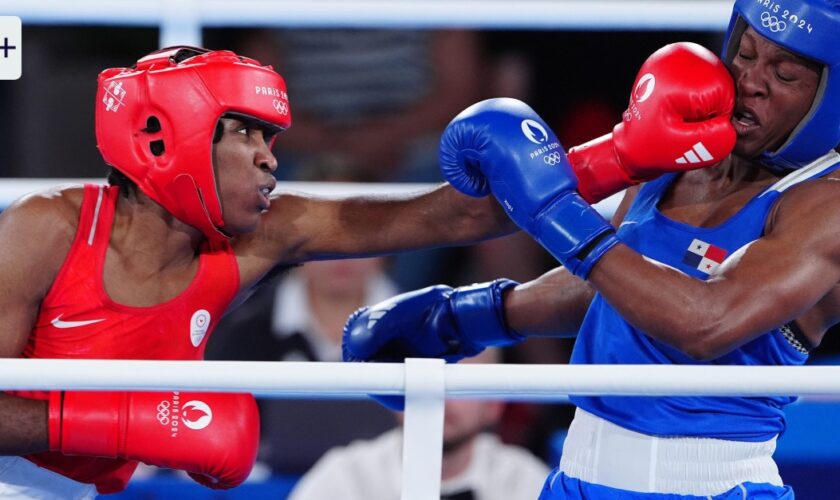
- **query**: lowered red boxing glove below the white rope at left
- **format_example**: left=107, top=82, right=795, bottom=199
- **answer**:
left=49, top=392, right=260, bottom=488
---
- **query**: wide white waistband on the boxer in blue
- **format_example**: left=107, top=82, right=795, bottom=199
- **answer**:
left=560, top=408, right=782, bottom=495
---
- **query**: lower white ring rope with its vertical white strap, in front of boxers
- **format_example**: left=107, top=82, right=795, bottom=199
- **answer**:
left=0, top=359, right=840, bottom=500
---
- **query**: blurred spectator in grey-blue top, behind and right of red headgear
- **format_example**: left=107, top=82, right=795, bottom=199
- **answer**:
left=233, top=29, right=481, bottom=182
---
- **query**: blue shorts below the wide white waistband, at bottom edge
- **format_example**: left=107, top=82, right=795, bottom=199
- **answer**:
left=539, top=469, right=794, bottom=500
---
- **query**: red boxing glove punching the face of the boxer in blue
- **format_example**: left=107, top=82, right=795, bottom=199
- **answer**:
left=568, top=42, right=736, bottom=203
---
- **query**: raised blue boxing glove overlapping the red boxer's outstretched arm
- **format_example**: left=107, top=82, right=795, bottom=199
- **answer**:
left=438, top=98, right=618, bottom=278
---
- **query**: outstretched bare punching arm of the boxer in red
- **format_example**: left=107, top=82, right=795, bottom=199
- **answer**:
left=234, top=185, right=516, bottom=286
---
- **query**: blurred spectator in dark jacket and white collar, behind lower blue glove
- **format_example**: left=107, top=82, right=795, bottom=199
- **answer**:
left=206, top=259, right=397, bottom=474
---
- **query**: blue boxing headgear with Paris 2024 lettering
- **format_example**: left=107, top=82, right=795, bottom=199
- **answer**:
left=723, top=0, right=840, bottom=169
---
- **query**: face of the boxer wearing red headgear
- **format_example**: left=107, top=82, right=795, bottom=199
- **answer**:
left=213, top=118, right=277, bottom=235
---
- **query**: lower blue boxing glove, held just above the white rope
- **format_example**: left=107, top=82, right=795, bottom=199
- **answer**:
left=341, top=279, right=524, bottom=410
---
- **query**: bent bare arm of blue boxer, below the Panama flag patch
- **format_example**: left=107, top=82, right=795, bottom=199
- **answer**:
left=590, top=180, right=840, bottom=359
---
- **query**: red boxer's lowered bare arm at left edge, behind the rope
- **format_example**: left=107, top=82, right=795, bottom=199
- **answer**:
left=0, top=190, right=76, bottom=455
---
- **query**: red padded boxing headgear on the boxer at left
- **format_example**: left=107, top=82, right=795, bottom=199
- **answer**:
left=96, top=47, right=292, bottom=238
